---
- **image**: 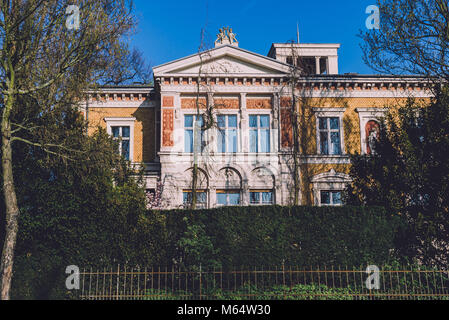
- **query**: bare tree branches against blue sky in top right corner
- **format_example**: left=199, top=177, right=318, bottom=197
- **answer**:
left=360, top=0, right=449, bottom=80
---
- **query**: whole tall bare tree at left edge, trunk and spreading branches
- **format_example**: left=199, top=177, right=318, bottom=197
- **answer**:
left=0, top=0, right=144, bottom=299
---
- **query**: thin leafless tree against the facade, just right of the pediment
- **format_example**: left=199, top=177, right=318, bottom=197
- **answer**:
left=279, top=41, right=351, bottom=205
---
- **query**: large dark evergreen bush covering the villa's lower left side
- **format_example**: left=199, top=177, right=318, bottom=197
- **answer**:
left=0, top=108, right=162, bottom=299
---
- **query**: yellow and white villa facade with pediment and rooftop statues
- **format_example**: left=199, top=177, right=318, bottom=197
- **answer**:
left=84, top=31, right=431, bottom=209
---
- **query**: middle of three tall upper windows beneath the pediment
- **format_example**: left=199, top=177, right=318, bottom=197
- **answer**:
left=217, top=115, right=238, bottom=153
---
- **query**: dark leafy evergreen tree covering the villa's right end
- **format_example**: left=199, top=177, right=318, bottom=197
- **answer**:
left=347, top=88, right=449, bottom=265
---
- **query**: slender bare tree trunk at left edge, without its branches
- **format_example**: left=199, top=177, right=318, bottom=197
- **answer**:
left=0, top=95, right=19, bottom=300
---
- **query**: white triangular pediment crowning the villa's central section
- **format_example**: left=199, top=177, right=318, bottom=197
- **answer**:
left=153, top=46, right=289, bottom=77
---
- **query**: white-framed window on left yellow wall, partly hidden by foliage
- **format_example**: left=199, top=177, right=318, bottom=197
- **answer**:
left=105, top=118, right=135, bottom=161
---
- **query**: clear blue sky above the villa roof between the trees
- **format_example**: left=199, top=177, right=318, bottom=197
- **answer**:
left=132, top=0, right=375, bottom=74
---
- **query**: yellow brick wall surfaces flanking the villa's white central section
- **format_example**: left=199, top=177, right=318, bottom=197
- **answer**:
left=89, top=94, right=428, bottom=205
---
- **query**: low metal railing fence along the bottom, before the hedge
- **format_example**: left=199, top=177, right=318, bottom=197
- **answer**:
left=78, top=266, right=449, bottom=300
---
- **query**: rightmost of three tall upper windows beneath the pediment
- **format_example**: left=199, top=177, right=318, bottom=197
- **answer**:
left=249, top=115, right=270, bottom=153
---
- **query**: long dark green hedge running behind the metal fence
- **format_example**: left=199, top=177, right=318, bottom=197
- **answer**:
left=6, top=204, right=405, bottom=299
